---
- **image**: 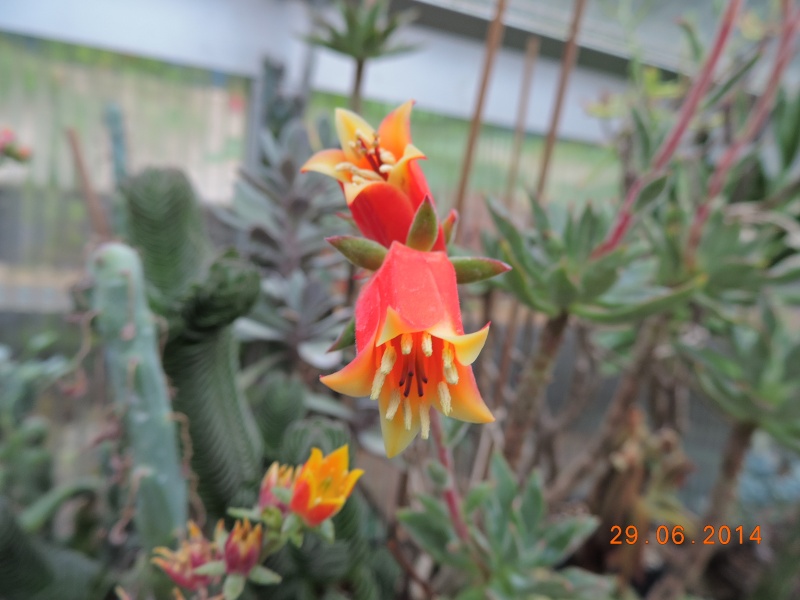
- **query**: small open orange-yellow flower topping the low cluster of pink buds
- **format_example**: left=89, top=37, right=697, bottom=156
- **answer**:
left=290, top=444, right=364, bottom=527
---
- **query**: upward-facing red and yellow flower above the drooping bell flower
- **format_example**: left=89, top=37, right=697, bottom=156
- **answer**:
left=301, top=101, right=445, bottom=250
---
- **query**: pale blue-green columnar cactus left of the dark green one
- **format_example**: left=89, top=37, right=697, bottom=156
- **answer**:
left=88, top=243, right=188, bottom=549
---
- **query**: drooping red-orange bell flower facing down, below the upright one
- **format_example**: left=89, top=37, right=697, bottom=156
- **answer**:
left=321, top=243, right=494, bottom=457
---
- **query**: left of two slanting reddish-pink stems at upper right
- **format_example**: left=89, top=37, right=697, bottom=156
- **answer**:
left=592, top=0, right=742, bottom=258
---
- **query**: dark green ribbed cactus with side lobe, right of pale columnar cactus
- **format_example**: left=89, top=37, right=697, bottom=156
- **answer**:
left=121, top=169, right=263, bottom=516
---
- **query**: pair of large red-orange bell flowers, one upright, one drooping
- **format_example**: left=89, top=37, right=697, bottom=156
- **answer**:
left=302, top=102, right=494, bottom=457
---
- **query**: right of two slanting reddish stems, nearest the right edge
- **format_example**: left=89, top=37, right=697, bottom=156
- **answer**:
left=686, top=1, right=800, bottom=265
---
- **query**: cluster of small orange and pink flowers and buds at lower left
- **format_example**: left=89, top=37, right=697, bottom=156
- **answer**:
left=151, top=445, right=363, bottom=591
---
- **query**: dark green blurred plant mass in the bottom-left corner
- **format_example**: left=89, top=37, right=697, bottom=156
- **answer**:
left=0, top=496, right=111, bottom=600
